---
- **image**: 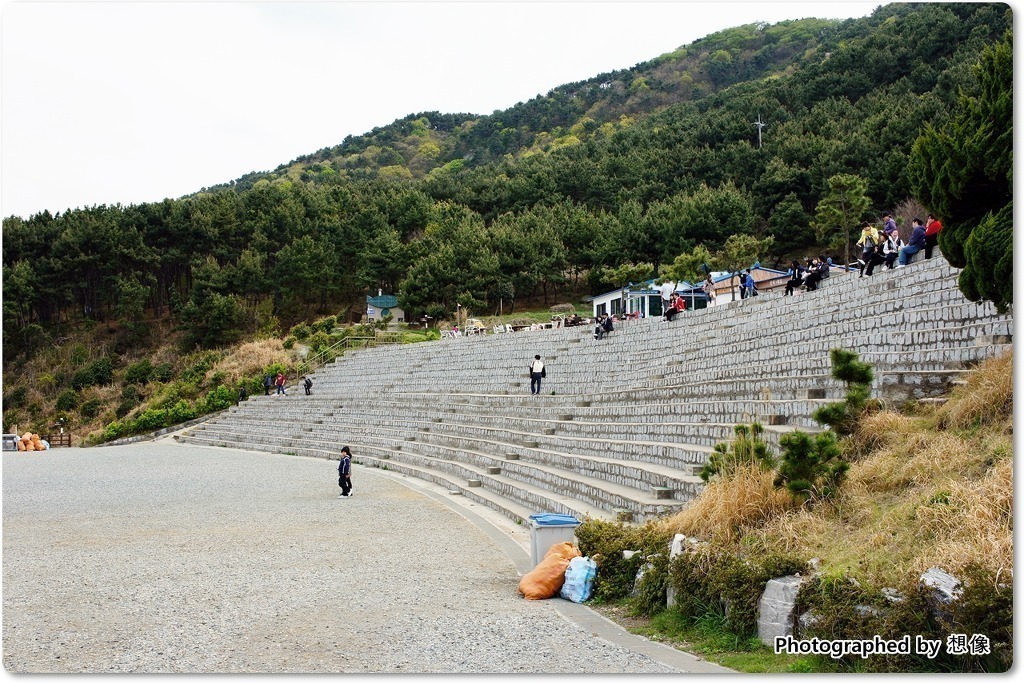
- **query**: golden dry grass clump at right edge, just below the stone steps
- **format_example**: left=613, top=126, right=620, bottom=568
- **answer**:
left=936, top=350, right=1014, bottom=430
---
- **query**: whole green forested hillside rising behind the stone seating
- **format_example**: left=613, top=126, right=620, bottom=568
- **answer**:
left=3, top=3, right=1012, bottom=444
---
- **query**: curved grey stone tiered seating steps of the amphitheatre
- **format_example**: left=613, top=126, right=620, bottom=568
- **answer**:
left=181, top=257, right=1013, bottom=521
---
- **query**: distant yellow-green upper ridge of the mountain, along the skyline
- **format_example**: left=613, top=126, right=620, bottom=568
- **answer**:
left=204, top=18, right=852, bottom=191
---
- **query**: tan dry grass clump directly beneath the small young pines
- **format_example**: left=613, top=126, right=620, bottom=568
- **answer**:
left=663, top=464, right=797, bottom=543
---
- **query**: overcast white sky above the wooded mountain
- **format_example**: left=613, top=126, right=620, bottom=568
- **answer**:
left=0, top=0, right=884, bottom=216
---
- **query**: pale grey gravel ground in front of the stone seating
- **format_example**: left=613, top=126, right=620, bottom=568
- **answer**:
left=3, top=440, right=696, bottom=673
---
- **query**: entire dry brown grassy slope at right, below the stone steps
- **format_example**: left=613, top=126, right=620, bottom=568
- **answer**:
left=663, top=354, right=1014, bottom=586
